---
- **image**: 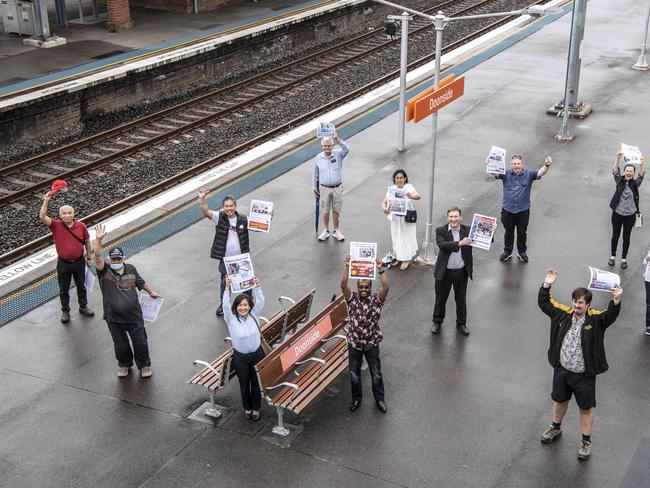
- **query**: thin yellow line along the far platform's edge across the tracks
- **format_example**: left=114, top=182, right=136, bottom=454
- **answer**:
left=0, top=0, right=338, bottom=100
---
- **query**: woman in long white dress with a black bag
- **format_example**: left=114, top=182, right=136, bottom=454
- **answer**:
left=381, top=169, right=420, bottom=269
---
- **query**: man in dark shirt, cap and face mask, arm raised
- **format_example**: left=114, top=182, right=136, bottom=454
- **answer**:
left=93, top=224, right=159, bottom=378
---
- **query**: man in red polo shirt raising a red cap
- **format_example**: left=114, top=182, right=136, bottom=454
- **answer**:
left=38, top=193, right=95, bottom=324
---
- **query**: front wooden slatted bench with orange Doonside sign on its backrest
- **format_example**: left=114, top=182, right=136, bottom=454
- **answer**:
left=255, top=295, right=348, bottom=436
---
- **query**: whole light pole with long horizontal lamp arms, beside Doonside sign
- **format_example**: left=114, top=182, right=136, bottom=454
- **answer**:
left=374, top=0, right=562, bottom=265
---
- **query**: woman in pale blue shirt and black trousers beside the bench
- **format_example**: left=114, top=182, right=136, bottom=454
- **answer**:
left=223, top=278, right=264, bottom=420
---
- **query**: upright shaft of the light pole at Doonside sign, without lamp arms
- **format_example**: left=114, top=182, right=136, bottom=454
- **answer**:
left=419, top=11, right=448, bottom=264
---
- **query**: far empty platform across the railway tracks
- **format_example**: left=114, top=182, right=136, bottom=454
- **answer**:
left=0, top=0, right=353, bottom=102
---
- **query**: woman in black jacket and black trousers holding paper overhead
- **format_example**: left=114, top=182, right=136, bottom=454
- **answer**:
left=607, top=151, right=645, bottom=269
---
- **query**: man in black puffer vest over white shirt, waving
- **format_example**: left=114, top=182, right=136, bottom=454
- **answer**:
left=199, top=188, right=250, bottom=315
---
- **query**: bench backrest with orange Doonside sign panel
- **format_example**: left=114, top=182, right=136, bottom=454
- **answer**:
left=255, top=295, right=348, bottom=391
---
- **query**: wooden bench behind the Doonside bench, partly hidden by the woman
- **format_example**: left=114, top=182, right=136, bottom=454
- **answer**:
left=186, top=289, right=316, bottom=418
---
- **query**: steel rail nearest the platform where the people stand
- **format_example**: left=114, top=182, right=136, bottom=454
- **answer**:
left=0, top=10, right=528, bottom=267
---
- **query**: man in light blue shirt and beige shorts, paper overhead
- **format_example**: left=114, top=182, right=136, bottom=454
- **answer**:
left=312, top=132, right=350, bottom=241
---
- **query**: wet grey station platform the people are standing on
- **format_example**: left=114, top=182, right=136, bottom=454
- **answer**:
left=0, top=0, right=650, bottom=488
